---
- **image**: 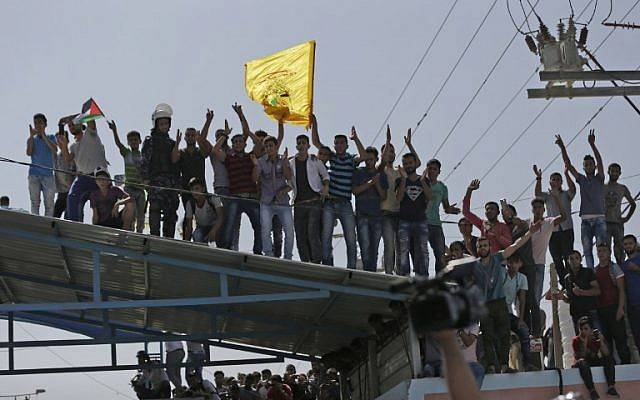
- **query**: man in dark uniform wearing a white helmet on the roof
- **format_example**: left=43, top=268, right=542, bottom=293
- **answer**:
left=140, top=103, right=182, bottom=238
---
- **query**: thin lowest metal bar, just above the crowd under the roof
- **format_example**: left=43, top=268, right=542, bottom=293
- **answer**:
left=0, top=356, right=284, bottom=376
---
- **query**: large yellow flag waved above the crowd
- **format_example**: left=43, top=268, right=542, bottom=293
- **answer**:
left=244, top=40, right=316, bottom=127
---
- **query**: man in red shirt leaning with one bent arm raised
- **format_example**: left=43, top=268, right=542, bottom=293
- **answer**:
left=462, top=179, right=511, bottom=253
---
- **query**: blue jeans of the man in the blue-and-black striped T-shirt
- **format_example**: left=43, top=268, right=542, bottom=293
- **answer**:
left=322, top=200, right=358, bottom=269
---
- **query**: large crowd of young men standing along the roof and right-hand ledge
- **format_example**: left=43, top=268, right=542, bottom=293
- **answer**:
left=5, top=104, right=640, bottom=400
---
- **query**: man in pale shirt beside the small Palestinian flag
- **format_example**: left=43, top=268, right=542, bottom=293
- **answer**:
left=57, top=114, right=109, bottom=222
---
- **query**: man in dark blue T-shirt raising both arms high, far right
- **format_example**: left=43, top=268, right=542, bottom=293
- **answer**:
left=556, top=129, right=607, bottom=268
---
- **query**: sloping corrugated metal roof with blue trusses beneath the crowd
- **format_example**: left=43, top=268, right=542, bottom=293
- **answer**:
left=0, top=210, right=406, bottom=355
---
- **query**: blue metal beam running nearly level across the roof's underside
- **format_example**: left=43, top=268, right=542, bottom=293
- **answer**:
left=0, top=290, right=329, bottom=312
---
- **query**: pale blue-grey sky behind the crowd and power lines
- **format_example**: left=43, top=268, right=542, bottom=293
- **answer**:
left=0, top=0, right=640, bottom=400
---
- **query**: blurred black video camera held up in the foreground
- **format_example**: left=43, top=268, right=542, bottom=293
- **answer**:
left=390, top=257, right=486, bottom=332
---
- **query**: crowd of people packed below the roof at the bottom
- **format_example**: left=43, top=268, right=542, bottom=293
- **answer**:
left=131, top=342, right=341, bottom=400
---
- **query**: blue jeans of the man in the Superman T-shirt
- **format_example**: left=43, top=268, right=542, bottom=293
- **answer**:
left=398, top=219, right=429, bottom=276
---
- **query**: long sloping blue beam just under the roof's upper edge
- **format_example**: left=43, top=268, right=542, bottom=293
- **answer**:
left=0, top=227, right=404, bottom=301
